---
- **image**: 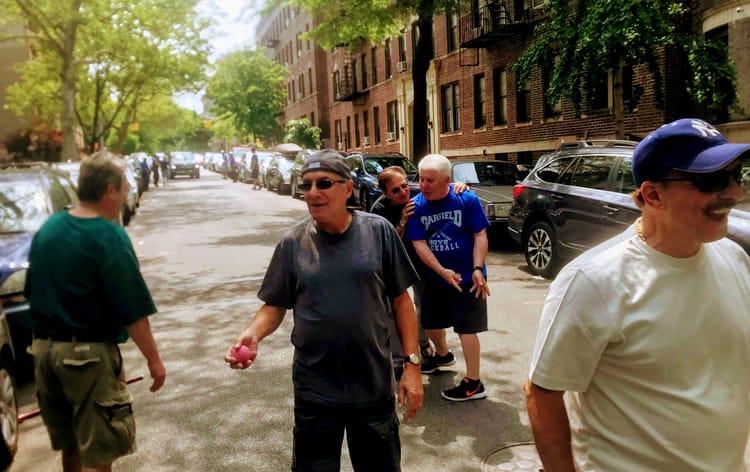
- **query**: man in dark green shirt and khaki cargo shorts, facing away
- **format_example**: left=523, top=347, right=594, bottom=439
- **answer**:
left=26, top=152, right=166, bottom=472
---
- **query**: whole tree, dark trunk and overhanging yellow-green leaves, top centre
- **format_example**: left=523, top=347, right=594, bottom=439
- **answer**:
left=290, top=0, right=461, bottom=159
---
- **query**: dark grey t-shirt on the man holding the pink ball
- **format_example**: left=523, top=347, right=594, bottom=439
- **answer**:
left=258, top=211, right=418, bottom=405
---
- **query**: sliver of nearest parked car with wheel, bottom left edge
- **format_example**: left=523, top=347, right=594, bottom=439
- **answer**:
left=0, top=306, right=18, bottom=470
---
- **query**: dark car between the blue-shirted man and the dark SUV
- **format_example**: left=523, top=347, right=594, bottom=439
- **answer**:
left=451, top=160, right=521, bottom=235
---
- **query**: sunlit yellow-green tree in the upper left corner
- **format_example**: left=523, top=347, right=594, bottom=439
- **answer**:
left=0, top=0, right=207, bottom=159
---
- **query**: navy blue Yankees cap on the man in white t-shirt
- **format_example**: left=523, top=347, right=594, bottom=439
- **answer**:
left=633, top=118, right=750, bottom=185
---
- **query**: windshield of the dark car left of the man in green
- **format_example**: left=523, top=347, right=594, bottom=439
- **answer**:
left=0, top=179, right=49, bottom=233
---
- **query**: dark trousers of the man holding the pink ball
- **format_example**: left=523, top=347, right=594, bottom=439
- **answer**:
left=292, top=398, right=401, bottom=472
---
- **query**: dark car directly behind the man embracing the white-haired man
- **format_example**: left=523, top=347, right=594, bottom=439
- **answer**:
left=346, top=152, right=419, bottom=211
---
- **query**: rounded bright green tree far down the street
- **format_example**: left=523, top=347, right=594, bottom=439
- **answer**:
left=206, top=49, right=287, bottom=141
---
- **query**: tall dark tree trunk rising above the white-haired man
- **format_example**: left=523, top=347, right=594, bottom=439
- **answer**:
left=411, top=0, right=435, bottom=162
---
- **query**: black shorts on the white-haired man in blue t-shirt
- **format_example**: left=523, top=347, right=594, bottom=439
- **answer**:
left=422, top=282, right=487, bottom=334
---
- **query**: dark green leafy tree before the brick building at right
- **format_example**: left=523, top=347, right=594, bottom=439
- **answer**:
left=514, top=0, right=736, bottom=138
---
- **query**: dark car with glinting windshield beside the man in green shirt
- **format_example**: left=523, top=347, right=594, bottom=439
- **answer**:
left=0, top=163, right=78, bottom=378
